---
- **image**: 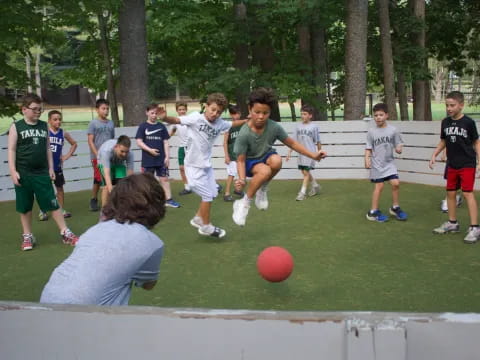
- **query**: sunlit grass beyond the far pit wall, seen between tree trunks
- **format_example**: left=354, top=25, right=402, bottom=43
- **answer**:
left=0, top=103, right=480, bottom=134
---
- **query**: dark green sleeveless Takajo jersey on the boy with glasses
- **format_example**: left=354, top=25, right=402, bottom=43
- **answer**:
left=15, top=119, right=48, bottom=175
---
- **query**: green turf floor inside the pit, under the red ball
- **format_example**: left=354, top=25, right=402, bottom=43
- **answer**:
left=0, top=180, right=480, bottom=312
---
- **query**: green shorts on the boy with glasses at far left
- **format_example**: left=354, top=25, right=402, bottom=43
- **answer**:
left=15, top=175, right=60, bottom=214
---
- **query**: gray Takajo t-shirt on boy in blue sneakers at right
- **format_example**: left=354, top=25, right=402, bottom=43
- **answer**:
left=365, top=124, right=403, bottom=179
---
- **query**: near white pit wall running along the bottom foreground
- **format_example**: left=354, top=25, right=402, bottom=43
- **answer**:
left=0, top=302, right=480, bottom=360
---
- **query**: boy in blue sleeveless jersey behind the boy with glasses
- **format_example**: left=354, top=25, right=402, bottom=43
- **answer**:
left=38, top=110, right=77, bottom=221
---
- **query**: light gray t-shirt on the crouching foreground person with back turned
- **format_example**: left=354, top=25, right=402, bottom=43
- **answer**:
left=40, top=220, right=163, bottom=305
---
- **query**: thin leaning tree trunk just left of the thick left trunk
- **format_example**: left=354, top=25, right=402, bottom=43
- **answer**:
left=97, top=14, right=120, bottom=127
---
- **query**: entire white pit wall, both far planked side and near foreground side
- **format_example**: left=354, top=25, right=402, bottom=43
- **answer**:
left=0, top=121, right=480, bottom=360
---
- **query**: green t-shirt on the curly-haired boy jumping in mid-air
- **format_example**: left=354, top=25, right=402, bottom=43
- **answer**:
left=234, top=119, right=288, bottom=159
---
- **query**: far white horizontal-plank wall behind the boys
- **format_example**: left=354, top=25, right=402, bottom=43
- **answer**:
left=0, top=120, right=472, bottom=201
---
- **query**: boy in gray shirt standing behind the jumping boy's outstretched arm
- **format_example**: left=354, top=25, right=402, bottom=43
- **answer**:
left=285, top=105, right=322, bottom=201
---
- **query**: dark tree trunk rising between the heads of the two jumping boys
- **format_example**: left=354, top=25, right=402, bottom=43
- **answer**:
left=233, top=1, right=250, bottom=119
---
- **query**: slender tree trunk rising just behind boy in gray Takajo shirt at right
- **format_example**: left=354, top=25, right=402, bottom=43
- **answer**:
left=377, top=0, right=398, bottom=120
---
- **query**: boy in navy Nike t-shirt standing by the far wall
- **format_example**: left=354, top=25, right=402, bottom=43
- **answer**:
left=135, top=104, right=180, bottom=208
